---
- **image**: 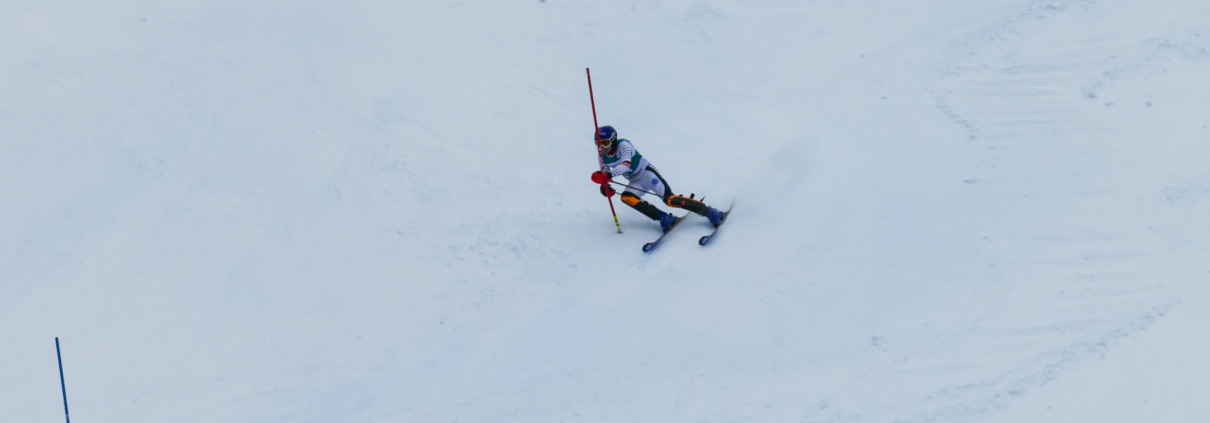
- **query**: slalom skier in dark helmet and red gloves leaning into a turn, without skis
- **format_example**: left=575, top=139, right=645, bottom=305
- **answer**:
left=593, top=126, right=722, bottom=232
